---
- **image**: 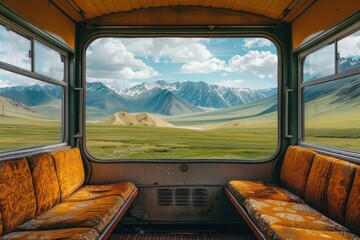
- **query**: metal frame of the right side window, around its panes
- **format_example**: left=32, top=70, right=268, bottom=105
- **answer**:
left=297, top=21, right=360, bottom=159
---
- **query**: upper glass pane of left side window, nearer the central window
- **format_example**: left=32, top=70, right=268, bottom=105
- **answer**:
left=35, top=41, right=65, bottom=80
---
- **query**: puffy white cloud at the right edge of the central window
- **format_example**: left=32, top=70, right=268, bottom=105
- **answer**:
left=225, top=50, right=277, bottom=79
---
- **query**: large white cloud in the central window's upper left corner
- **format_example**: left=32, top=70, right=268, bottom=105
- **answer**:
left=86, top=38, right=159, bottom=79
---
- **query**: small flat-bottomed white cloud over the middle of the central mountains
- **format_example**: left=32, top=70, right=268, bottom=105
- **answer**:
left=180, top=57, right=225, bottom=74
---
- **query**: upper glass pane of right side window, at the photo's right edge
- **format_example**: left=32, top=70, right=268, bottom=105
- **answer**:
left=338, top=31, right=360, bottom=72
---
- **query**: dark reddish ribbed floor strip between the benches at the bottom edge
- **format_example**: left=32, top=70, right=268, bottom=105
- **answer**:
left=109, top=233, right=256, bottom=240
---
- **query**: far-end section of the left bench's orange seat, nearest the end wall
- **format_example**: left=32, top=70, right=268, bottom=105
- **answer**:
left=65, top=182, right=135, bottom=202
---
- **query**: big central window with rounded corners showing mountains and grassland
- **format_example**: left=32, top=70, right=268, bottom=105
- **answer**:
left=84, top=37, right=278, bottom=160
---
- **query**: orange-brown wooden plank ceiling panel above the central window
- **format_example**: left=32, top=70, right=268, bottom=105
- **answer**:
left=53, top=0, right=313, bottom=24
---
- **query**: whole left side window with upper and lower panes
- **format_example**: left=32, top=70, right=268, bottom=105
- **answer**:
left=0, top=25, right=67, bottom=152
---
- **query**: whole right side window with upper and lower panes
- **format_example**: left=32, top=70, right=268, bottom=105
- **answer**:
left=301, top=27, right=360, bottom=152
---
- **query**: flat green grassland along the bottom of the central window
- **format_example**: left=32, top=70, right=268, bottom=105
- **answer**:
left=86, top=124, right=277, bottom=159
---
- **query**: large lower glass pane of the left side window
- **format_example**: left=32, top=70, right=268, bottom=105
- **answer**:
left=0, top=69, right=63, bottom=151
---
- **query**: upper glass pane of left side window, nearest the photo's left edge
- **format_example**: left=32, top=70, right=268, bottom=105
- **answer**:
left=0, top=25, right=31, bottom=71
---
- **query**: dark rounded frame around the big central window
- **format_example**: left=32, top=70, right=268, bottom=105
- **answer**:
left=79, top=32, right=286, bottom=164
